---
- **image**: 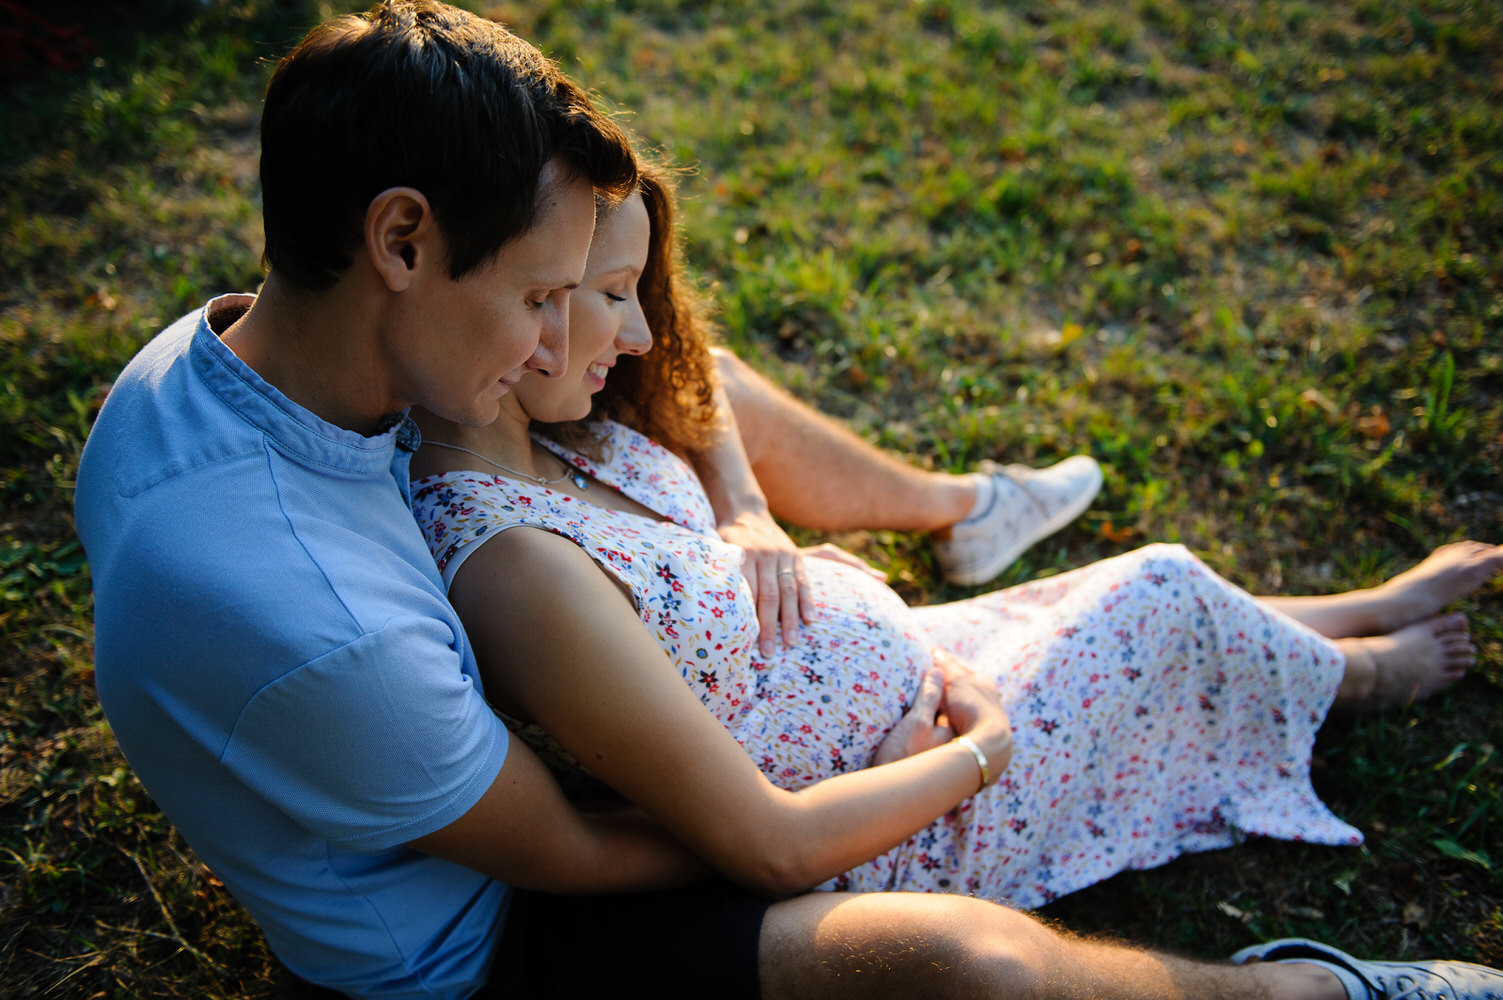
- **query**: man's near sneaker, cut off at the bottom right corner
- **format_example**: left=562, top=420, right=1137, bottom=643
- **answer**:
left=1231, top=937, right=1503, bottom=1000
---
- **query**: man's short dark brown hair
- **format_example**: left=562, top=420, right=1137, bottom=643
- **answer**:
left=262, top=0, right=636, bottom=290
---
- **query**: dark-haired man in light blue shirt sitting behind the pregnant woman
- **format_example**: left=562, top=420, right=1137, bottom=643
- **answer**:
left=77, top=0, right=1503, bottom=998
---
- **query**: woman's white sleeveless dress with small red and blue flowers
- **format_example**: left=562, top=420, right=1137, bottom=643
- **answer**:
left=412, top=424, right=1362, bottom=907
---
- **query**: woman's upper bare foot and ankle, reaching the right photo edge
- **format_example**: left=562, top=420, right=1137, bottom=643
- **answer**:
left=1261, top=541, right=1503, bottom=639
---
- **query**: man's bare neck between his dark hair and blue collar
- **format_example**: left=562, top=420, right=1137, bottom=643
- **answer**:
left=219, top=272, right=407, bottom=435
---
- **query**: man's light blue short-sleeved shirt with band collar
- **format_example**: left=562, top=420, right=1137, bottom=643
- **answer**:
left=77, top=296, right=510, bottom=997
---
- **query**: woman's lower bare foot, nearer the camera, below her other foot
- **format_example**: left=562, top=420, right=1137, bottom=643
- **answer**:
left=1333, top=607, right=1477, bottom=710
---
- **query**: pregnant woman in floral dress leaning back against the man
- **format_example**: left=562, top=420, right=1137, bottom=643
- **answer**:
left=413, top=170, right=1503, bottom=907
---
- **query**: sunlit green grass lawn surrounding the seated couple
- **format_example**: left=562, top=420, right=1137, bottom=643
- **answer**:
left=0, top=0, right=1503, bottom=998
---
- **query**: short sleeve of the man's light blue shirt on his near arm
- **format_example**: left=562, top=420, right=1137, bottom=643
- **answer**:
left=224, top=618, right=508, bottom=850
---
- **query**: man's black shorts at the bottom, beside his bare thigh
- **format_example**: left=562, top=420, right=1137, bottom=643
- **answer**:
left=475, top=883, right=771, bottom=1000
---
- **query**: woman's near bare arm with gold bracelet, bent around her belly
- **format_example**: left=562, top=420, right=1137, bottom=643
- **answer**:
left=451, top=528, right=1012, bottom=895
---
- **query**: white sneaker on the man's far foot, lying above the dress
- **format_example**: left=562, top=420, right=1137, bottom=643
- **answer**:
left=933, top=454, right=1102, bottom=585
